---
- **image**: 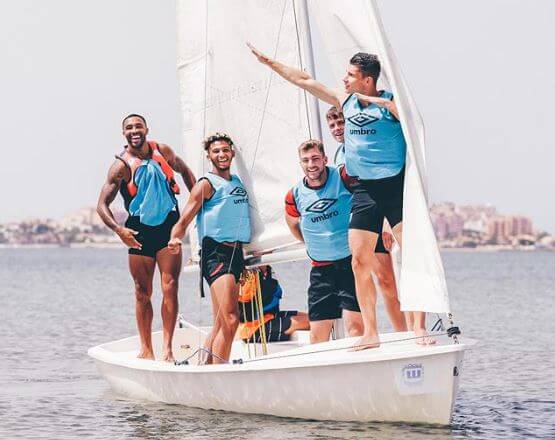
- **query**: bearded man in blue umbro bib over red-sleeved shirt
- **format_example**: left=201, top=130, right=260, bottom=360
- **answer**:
left=285, top=140, right=363, bottom=343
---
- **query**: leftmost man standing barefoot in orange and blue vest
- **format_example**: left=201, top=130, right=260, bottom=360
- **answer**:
left=97, top=114, right=195, bottom=362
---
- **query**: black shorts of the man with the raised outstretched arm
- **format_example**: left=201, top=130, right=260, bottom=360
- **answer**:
left=349, top=168, right=405, bottom=235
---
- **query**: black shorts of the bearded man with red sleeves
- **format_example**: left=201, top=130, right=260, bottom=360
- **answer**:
left=308, top=256, right=360, bottom=321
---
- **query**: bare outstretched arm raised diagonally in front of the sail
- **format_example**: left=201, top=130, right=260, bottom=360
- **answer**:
left=247, top=43, right=347, bottom=108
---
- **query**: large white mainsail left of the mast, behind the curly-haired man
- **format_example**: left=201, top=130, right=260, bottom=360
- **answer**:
left=177, top=0, right=314, bottom=260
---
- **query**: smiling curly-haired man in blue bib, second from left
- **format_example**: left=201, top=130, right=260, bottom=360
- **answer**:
left=168, top=133, right=251, bottom=363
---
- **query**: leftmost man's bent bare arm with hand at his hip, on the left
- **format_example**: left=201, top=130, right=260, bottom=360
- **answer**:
left=96, top=160, right=141, bottom=249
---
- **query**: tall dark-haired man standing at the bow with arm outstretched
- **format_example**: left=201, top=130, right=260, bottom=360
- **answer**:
left=249, top=44, right=435, bottom=348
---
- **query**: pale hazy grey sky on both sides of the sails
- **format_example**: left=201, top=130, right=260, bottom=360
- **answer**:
left=0, top=0, right=555, bottom=232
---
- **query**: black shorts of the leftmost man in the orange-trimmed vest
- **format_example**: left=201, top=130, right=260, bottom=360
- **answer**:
left=125, top=211, right=179, bottom=258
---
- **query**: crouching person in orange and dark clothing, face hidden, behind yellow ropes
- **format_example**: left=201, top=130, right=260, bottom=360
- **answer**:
left=239, top=265, right=310, bottom=343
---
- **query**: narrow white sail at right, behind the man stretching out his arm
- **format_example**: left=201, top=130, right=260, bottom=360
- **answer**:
left=309, top=0, right=450, bottom=313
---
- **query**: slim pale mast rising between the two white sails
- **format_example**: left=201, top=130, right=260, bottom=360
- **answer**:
left=294, top=0, right=322, bottom=139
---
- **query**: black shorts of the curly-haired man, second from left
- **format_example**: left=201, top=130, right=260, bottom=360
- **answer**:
left=200, top=237, right=245, bottom=286
